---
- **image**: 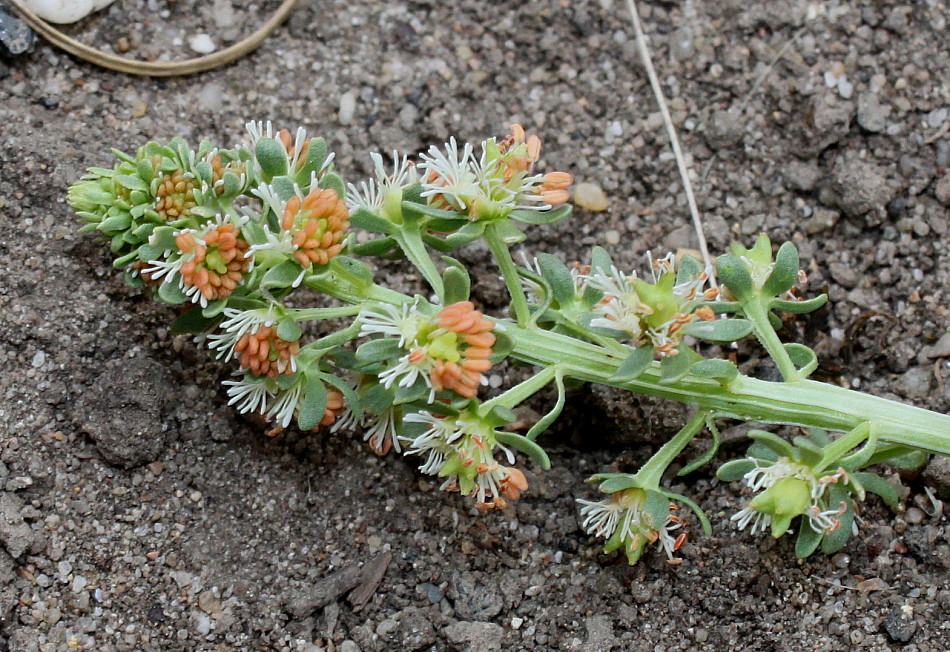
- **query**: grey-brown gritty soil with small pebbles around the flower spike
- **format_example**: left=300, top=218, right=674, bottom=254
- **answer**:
left=0, top=0, right=950, bottom=652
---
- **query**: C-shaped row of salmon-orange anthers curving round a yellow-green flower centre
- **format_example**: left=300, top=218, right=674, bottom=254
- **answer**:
left=430, top=301, right=495, bottom=398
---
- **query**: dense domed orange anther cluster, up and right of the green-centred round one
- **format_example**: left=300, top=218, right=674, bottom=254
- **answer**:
left=281, top=187, right=350, bottom=267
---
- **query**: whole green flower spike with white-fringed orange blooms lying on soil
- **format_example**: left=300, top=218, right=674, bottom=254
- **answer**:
left=68, top=123, right=950, bottom=564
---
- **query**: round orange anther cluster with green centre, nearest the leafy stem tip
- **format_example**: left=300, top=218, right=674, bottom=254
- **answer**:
left=175, top=222, right=250, bottom=302
